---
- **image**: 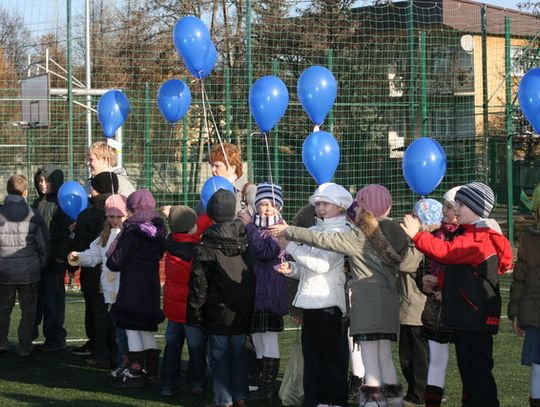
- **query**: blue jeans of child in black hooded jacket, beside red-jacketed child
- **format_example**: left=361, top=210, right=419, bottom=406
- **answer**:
left=208, top=335, right=248, bottom=405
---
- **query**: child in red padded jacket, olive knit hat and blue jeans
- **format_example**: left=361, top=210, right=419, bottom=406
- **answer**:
left=161, top=206, right=207, bottom=396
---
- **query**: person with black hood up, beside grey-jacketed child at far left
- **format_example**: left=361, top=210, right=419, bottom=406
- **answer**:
left=32, top=164, right=73, bottom=352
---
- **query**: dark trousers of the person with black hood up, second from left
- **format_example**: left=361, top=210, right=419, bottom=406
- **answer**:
left=34, top=262, right=66, bottom=346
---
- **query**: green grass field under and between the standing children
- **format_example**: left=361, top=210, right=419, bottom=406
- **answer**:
left=0, top=276, right=529, bottom=407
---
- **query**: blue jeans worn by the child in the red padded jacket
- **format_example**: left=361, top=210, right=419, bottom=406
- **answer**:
left=161, top=321, right=208, bottom=389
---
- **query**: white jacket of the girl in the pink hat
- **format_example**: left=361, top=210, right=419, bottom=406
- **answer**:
left=79, top=228, right=121, bottom=304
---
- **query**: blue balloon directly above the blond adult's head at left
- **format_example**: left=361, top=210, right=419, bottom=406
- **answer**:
left=97, top=90, right=129, bottom=138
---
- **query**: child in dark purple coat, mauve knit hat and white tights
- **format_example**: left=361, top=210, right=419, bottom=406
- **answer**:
left=106, top=189, right=167, bottom=387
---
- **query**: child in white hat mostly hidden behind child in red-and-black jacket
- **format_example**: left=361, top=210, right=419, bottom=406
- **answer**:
left=422, top=187, right=460, bottom=407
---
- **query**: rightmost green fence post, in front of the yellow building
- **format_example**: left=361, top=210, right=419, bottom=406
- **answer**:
left=504, top=16, right=514, bottom=243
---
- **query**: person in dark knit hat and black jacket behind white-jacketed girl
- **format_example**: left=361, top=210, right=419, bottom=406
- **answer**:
left=70, top=172, right=118, bottom=368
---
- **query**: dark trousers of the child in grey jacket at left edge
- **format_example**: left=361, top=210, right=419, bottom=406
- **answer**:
left=0, top=282, right=39, bottom=353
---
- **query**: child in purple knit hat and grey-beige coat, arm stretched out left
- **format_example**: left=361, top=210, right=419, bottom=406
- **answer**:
left=276, top=185, right=421, bottom=407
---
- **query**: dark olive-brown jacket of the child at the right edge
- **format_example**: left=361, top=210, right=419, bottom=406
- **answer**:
left=508, top=228, right=540, bottom=329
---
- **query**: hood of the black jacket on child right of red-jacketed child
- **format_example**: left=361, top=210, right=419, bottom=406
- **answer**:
left=201, top=220, right=248, bottom=257
